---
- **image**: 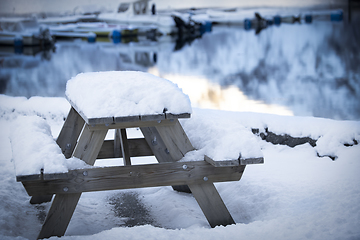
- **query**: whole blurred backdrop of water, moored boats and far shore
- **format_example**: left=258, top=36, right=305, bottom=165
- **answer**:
left=0, top=0, right=360, bottom=120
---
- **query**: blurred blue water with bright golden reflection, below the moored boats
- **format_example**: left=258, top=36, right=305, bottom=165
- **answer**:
left=0, top=10, right=360, bottom=120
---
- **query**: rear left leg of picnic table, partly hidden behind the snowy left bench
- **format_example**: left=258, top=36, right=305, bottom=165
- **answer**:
left=30, top=107, right=85, bottom=204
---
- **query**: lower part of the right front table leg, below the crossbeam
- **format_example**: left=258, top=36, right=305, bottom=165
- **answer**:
left=188, top=183, right=235, bottom=227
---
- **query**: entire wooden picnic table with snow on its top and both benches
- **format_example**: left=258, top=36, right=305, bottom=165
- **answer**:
left=12, top=71, right=263, bottom=238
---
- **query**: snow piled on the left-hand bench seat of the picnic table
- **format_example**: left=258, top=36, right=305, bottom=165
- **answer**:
left=10, top=116, right=87, bottom=176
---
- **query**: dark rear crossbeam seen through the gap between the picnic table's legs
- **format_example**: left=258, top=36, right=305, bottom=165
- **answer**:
left=97, top=138, right=154, bottom=159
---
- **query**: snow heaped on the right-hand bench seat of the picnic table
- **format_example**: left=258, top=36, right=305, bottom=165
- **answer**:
left=181, top=110, right=263, bottom=161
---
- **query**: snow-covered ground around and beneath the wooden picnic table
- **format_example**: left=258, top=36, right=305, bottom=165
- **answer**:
left=0, top=95, right=360, bottom=239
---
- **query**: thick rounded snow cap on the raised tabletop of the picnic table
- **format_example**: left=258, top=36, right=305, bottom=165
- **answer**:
left=65, top=71, right=191, bottom=118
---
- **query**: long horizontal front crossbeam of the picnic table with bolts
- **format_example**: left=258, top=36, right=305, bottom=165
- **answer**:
left=23, top=161, right=245, bottom=196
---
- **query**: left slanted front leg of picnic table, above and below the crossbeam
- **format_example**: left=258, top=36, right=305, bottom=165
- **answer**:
left=38, top=126, right=107, bottom=239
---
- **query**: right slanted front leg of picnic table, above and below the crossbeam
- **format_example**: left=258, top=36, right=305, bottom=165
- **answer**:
left=141, top=120, right=235, bottom=227
